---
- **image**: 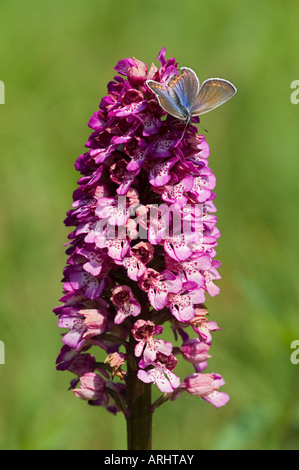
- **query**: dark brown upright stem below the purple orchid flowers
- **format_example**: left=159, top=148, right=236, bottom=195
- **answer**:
left=126, top=335, right=152, bottom=450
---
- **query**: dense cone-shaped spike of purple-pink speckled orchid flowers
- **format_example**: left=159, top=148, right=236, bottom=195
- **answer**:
left=54, top=48, right=228, bottom=414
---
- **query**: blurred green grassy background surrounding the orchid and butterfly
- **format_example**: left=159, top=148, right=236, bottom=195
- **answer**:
left=0, top=0, right=299, bottom=450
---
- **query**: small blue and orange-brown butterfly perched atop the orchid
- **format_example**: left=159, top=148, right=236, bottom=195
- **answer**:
left=146, top=67, right=237, bottom=124
